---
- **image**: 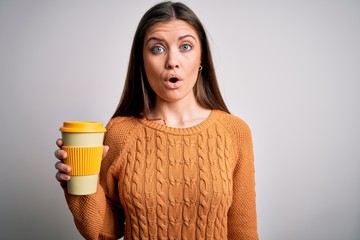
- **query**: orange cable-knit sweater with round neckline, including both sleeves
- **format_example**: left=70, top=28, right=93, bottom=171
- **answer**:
left=65, top=110, right=258, bottom=240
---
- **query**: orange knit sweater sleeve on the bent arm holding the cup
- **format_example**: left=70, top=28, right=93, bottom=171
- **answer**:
left=64, top=118, right=125, bottom=240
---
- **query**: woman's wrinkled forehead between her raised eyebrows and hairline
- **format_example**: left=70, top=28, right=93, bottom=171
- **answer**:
left=145, top=19, right=198, bottom=41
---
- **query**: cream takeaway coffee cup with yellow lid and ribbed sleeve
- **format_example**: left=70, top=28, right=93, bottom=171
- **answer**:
left=59, top=122, right=106, bottom=195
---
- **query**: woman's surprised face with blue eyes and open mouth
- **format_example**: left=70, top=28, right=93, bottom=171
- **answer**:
left=143, top=20, right=201, bottom=106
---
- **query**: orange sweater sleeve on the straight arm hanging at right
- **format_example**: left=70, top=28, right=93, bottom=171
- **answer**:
left=228, top=119, right=258, bottom=240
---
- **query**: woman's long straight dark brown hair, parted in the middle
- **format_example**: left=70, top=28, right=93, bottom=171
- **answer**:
left=112, top=1, right=229, bottom=118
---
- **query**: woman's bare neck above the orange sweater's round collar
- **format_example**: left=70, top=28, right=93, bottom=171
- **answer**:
left=148, top=97, right=211, bottom=128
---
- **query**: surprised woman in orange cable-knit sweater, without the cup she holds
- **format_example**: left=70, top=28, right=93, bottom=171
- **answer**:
left=55, top=2, right=258, bottom=240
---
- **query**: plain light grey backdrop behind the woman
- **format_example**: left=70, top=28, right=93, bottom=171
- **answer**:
left=0, top=0, right=360, bottom=240
